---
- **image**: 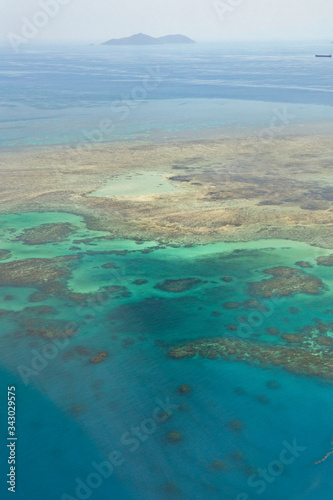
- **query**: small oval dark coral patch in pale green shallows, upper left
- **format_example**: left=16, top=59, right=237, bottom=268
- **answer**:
left=17, top=222, right=75, bottom=245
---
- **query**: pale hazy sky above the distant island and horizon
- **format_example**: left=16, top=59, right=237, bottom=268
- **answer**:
left=0, top=0, right=333, bottom=43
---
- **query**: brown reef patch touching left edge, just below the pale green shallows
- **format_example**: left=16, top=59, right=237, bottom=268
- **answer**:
left=0, top=256, right=77, bottom=286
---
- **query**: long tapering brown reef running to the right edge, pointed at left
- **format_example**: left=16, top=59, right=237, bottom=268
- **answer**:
left=169, top=337, right=333, bottom=379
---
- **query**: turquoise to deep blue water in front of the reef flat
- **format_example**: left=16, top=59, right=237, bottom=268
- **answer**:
left=0, top=213, right=333, bottom=500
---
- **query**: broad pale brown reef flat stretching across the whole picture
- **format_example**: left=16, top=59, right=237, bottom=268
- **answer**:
left=0, top=135, right=333, bottom=248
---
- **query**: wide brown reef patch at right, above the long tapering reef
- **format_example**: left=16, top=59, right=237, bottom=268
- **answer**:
left=249, top=266, right=325, bottom=298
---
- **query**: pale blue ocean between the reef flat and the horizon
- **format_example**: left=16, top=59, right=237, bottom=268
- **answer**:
left=0, top=41, right=333, bottom=146
